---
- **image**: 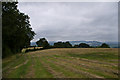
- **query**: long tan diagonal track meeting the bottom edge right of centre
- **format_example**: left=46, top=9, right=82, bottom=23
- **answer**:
left=45, top=56, right=104, bottom=78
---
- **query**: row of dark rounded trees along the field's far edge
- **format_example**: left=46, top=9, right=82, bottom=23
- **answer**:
left=36, top=38, right=110, bottom=49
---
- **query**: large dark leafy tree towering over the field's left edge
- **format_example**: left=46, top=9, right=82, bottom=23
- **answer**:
left=2, top=2, right=35, bottom=58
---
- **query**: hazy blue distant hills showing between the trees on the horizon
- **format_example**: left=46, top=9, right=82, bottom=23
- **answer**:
left=31, top=41, right=120, bottom=48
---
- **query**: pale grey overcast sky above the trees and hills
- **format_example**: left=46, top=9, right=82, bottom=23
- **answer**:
left=18, top=2, right=118, bottom=42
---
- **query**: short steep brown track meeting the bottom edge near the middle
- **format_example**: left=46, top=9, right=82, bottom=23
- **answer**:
left=41, top=56, right=65, bottom=78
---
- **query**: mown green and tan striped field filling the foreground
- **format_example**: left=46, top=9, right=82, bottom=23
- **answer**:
left=2, top=48, right=118, bottom=78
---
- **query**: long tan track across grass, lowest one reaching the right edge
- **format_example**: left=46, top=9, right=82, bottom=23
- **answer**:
left=53, top=57, right=118, bottom=76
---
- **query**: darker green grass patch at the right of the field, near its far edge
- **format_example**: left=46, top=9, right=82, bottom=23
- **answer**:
left=68, top=52, right=118, bottom=60
